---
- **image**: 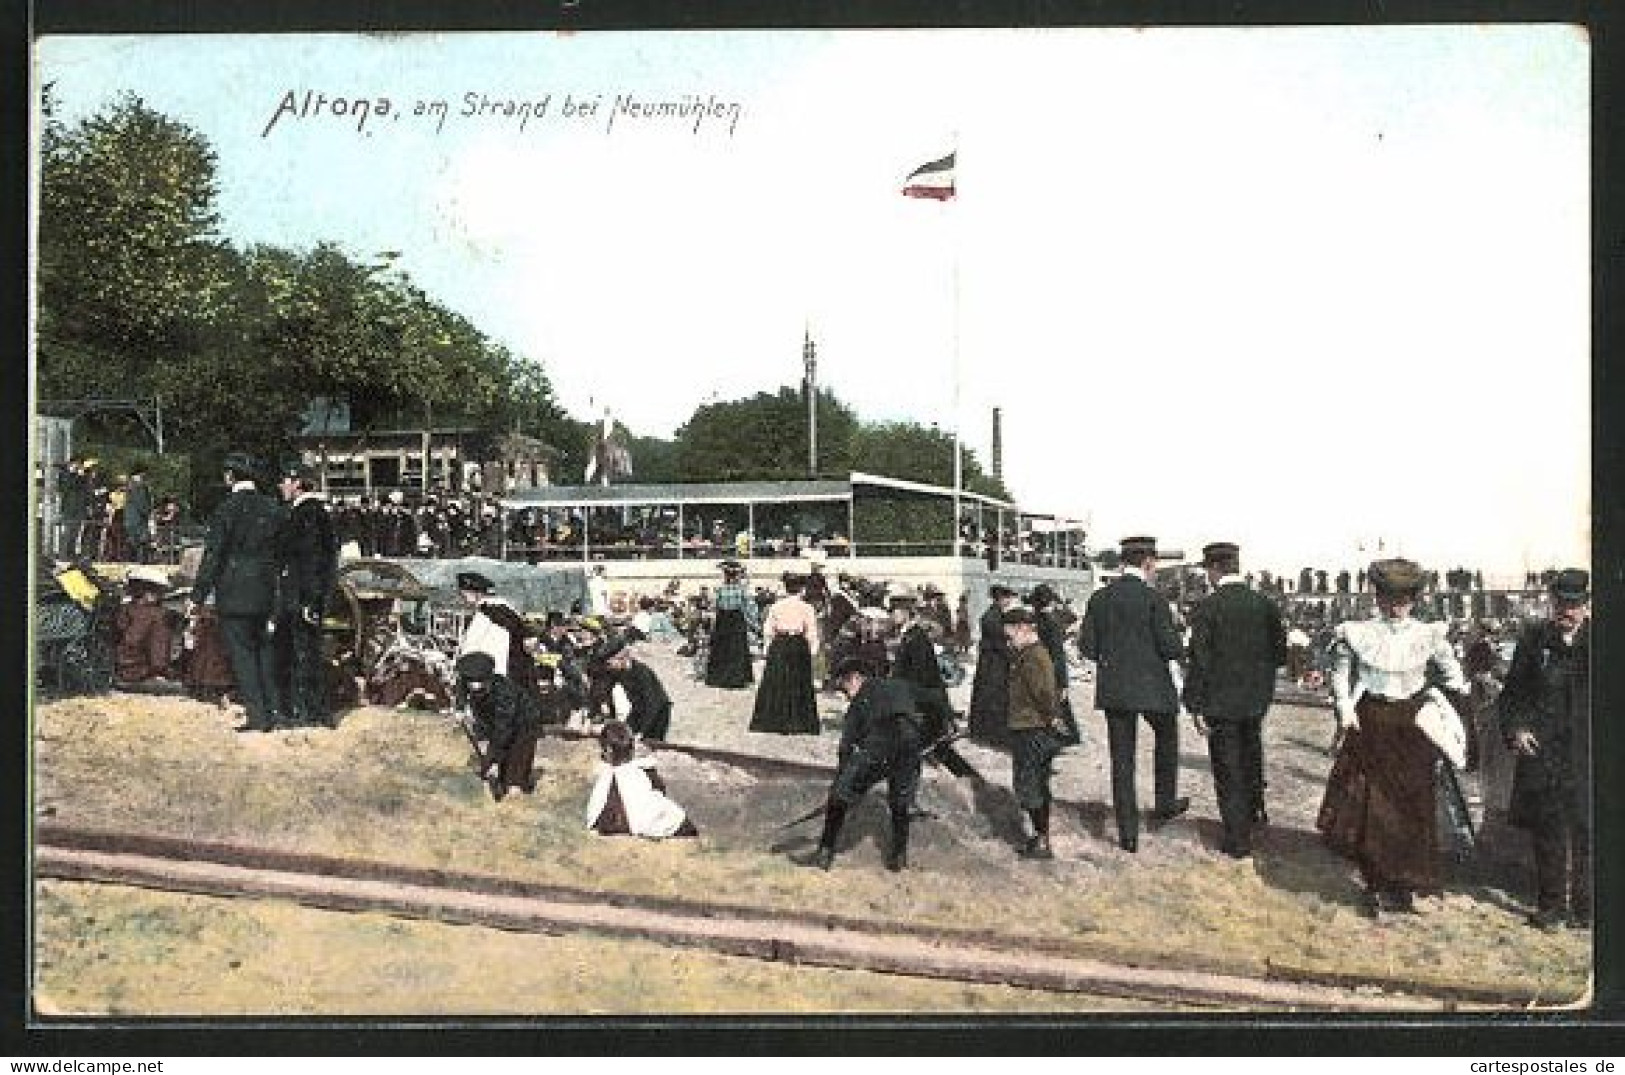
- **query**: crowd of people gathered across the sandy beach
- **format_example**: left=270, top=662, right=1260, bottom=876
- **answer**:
left=57, top=456, right=1593, bottom=929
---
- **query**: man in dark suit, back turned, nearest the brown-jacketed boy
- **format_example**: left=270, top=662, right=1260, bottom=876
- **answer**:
left=1077, top=538, right=1191, bottom=851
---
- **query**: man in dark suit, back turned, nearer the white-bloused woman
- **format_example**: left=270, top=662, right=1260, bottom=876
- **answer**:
left=1185, top=541, right=1287, bottom=859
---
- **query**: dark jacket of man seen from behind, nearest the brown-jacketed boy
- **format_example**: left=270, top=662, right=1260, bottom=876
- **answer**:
left=1077, top=575, right=1183, bottom=713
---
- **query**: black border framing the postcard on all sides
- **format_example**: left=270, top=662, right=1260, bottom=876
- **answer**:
left=0, top=0, right=1625, bottom=1062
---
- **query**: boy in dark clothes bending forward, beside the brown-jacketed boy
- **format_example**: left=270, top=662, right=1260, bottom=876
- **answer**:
left=800, top=659, right=920, bottom=872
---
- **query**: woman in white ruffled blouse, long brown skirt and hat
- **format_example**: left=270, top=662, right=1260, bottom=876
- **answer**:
left=1316, top=560, right=1467, bottom=917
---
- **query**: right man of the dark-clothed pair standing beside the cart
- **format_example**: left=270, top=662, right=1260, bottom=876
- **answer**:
left=276, top=463, right=338, bottom=727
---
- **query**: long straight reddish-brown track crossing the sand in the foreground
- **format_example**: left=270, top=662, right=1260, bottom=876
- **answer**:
left=34, top=823, right=1534, bottom=1013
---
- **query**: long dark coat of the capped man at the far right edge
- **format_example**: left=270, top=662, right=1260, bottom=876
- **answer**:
left=1497, top=622, right=1591, bottom=828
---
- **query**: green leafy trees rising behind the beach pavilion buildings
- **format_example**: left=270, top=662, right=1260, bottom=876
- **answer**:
left=36, top=86, right=1006, bottom=519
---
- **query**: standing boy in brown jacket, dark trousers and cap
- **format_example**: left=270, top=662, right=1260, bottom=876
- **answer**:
left=1001, top=607, right=1068, bottom=859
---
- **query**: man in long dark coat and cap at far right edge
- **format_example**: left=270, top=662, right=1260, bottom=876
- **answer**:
left=1500, top=568, right=1593, bottom=929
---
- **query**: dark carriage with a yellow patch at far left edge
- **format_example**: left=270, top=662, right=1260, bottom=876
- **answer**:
left=34, top=562, right=119, bottom=695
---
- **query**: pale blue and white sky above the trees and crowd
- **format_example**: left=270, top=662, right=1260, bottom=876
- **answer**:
left=36, top=26, right=1591, bottom=575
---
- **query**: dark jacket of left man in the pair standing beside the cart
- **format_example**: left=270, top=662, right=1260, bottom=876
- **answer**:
left=192, top=489, right=283, bottom=617
